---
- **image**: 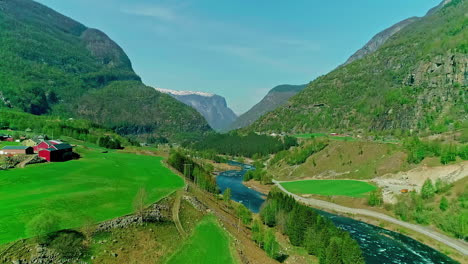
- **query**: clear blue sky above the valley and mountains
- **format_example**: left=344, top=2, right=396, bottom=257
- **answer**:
left=37, top=0, right=441, bottom=114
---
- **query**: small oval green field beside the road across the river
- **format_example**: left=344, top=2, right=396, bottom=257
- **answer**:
left=281, top=180, right=377, bottom=198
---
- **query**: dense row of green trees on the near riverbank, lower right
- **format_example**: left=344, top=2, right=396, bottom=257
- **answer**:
left=260, top=190, right=364, bottom=264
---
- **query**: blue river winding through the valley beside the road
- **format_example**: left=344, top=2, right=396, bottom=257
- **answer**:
left=216, top=162, right=457, bottom=264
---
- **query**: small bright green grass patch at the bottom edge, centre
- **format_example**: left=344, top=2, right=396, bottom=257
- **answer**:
left=167, top=216, right=236, bottom=264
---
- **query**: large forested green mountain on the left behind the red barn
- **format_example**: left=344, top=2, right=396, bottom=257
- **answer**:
left=0, top=0, right=210, bottom=140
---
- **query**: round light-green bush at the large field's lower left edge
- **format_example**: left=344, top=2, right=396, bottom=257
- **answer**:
left=26, top=211, right=60, bottom=244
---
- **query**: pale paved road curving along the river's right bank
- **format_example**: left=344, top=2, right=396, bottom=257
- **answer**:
left=273, top=180, right=468, bottom=256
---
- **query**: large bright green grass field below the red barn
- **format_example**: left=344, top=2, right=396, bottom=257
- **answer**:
left=0, top=145, right=184, bottom=244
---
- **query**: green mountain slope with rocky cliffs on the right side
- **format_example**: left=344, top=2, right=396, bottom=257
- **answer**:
left=246, top=0, right=468, bottom=134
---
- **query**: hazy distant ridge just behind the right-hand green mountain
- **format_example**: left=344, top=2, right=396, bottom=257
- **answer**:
left=229, top=84, right=307, bottom=130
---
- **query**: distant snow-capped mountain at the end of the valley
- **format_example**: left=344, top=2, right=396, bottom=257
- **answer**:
left=156, top=88, right=237, bottom=131
